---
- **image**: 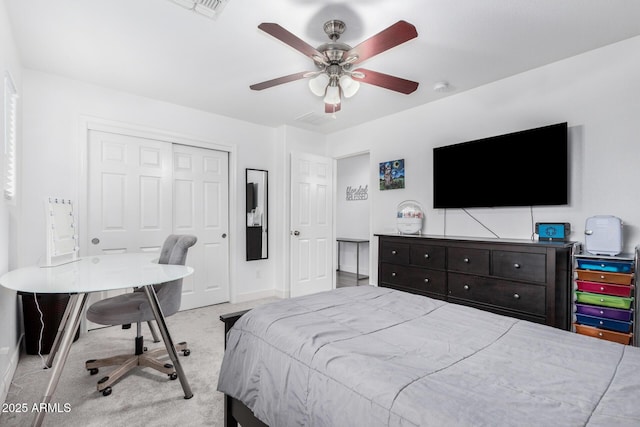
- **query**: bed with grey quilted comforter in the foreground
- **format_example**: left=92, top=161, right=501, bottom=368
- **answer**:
left=218, top=286, right=640, bottom=427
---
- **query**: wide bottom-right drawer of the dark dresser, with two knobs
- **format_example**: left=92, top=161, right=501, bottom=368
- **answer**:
left=448, top=273, right=546, bottom=316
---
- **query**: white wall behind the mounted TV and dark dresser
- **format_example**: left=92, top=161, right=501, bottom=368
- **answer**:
left=329, top=37, right=640, bottom=284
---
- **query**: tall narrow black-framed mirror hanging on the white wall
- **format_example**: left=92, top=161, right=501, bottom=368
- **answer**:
left=246, top=169, right=269, bottom=261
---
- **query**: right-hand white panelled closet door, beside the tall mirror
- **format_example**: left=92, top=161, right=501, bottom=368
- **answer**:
left=173, top=144, right=229, bottom=310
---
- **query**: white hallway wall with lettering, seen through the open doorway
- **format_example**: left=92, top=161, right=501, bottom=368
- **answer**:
left=335, top=153, right=372, bottom=274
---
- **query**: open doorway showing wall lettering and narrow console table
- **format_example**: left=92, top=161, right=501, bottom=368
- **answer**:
left=335, top=153, right=371, bottom=288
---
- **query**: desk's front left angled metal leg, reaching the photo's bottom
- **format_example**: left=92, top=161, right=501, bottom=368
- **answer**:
left=33, top=294, right=87, bottom=427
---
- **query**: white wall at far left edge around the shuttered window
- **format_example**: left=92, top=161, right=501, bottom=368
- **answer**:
left=0, top=2, right=22, bottom=403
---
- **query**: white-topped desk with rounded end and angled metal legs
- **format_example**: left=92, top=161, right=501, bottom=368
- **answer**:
left=0, top=253, right=193, bottom=426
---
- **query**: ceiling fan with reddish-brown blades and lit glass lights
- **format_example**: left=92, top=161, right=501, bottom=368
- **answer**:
left=249, top=19, right=418, bottom=113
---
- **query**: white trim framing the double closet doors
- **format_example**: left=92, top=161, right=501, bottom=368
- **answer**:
left=76, top=115, right=238, bottom=302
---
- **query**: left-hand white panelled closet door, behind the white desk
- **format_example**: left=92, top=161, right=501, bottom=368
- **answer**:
left=84, top=130, right=173, bottom=329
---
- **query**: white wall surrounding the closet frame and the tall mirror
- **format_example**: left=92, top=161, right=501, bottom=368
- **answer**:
left=18, top=70, right=278, bottom=299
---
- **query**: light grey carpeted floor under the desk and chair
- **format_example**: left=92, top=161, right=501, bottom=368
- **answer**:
left=0, top=298, right=276, bottom=427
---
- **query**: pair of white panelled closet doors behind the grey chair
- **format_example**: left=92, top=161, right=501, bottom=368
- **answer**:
left=86, top=130, right=229, bottom=330
